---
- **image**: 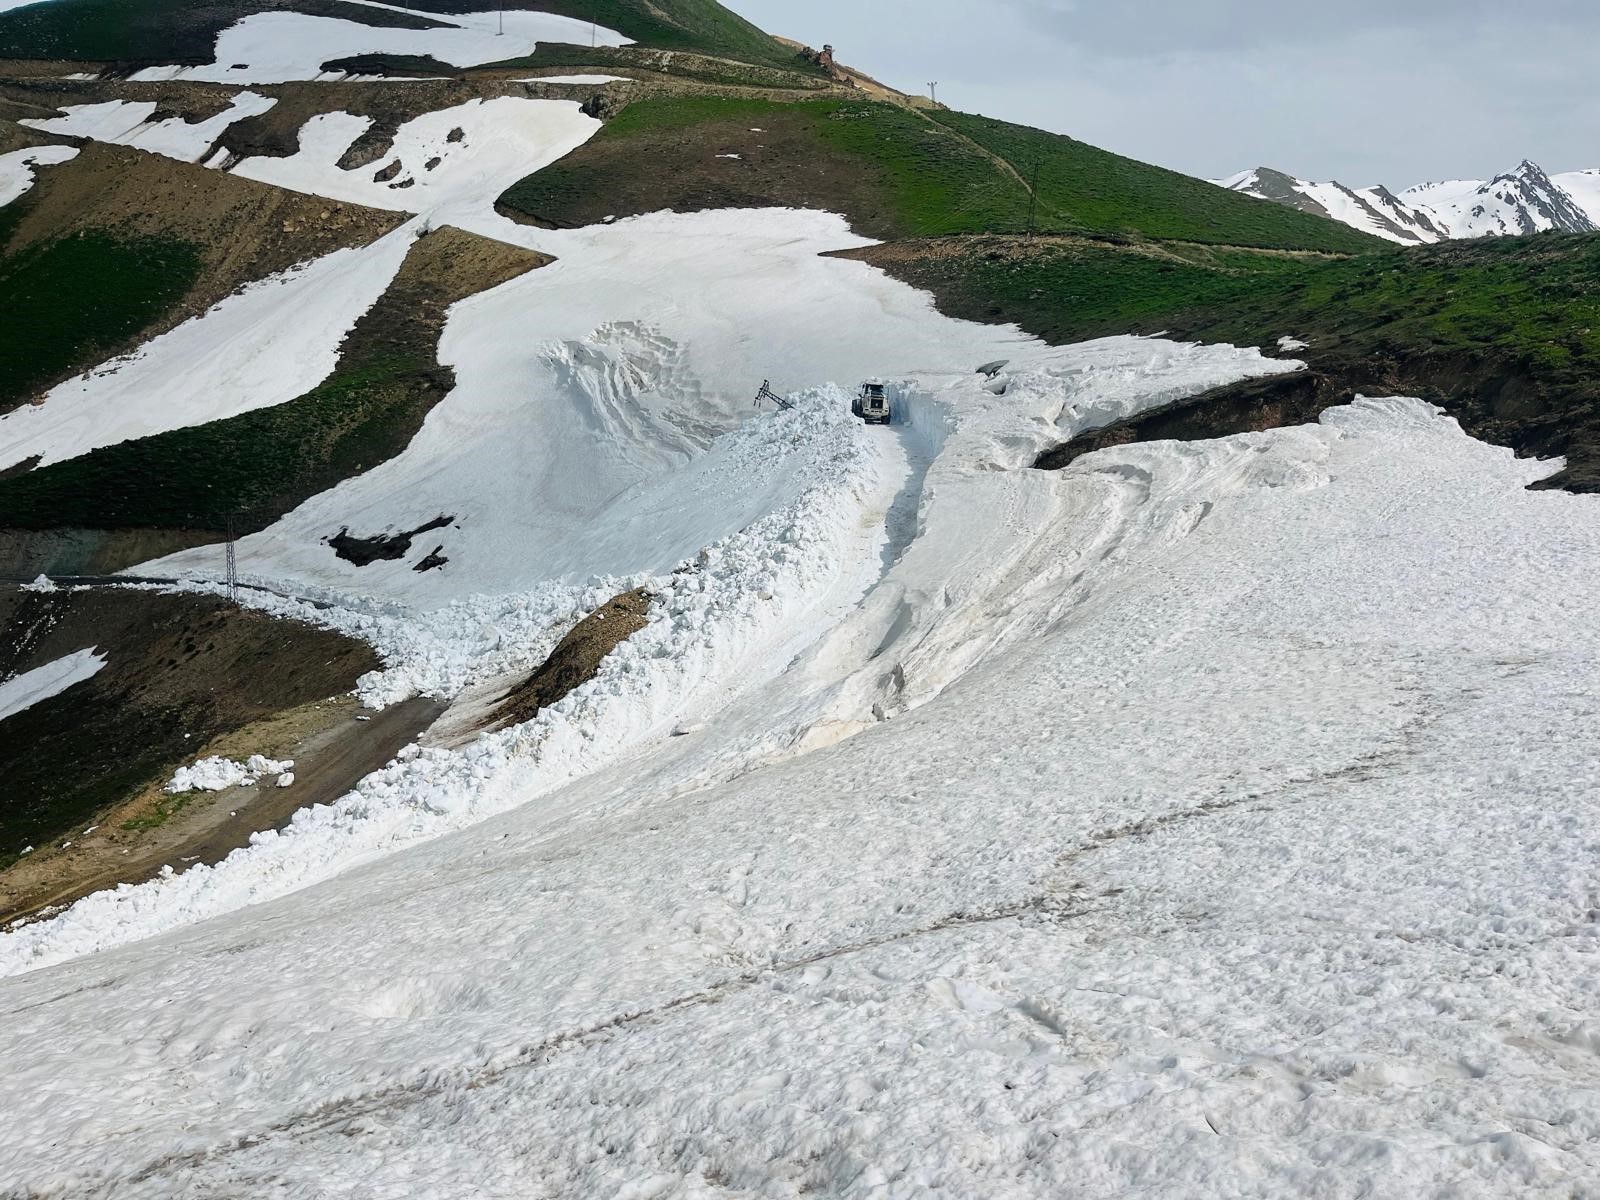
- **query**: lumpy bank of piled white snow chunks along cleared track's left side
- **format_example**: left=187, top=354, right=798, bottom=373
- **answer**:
left=0, top=390, right=882, bottom=973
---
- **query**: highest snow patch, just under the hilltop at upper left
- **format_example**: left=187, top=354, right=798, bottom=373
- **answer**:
left=133, top=5, right=629, bottom=83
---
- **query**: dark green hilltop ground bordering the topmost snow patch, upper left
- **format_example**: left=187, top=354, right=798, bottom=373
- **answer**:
left=0, top=0, right=795, bottom=66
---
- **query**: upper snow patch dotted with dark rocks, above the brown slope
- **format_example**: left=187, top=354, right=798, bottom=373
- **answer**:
left=232, top=96, right=600, bottom=232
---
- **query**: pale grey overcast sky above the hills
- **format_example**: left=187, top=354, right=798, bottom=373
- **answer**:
left=725, top=0, right=1600, bottom=189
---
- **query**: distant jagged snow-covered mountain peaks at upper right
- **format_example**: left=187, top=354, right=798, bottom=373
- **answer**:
left=1213, top=162, right=1600, bottom=243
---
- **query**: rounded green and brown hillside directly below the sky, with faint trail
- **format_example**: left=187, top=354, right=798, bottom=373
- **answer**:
left=502, top=96, right=1381, bottom=253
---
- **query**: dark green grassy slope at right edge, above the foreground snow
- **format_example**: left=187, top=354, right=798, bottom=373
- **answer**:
left=859, top=234, right=1600, bottom=491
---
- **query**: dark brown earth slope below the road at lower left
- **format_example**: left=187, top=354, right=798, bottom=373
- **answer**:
left=0, top=589, right=378, bottom=862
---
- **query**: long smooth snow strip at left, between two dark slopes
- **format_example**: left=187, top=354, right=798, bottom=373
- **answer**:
left=0, top=224, right=418, bottom=469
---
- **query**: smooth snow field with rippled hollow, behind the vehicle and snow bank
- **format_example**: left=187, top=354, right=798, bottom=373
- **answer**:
left=150, top=210, right=1045, bottom=610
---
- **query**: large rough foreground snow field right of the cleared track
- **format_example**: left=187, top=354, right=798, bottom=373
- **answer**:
left=9, top=390, right=1600, bottom=1197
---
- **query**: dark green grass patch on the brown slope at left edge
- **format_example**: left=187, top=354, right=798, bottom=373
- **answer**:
left=0, top=224, right=202, bottom=411
